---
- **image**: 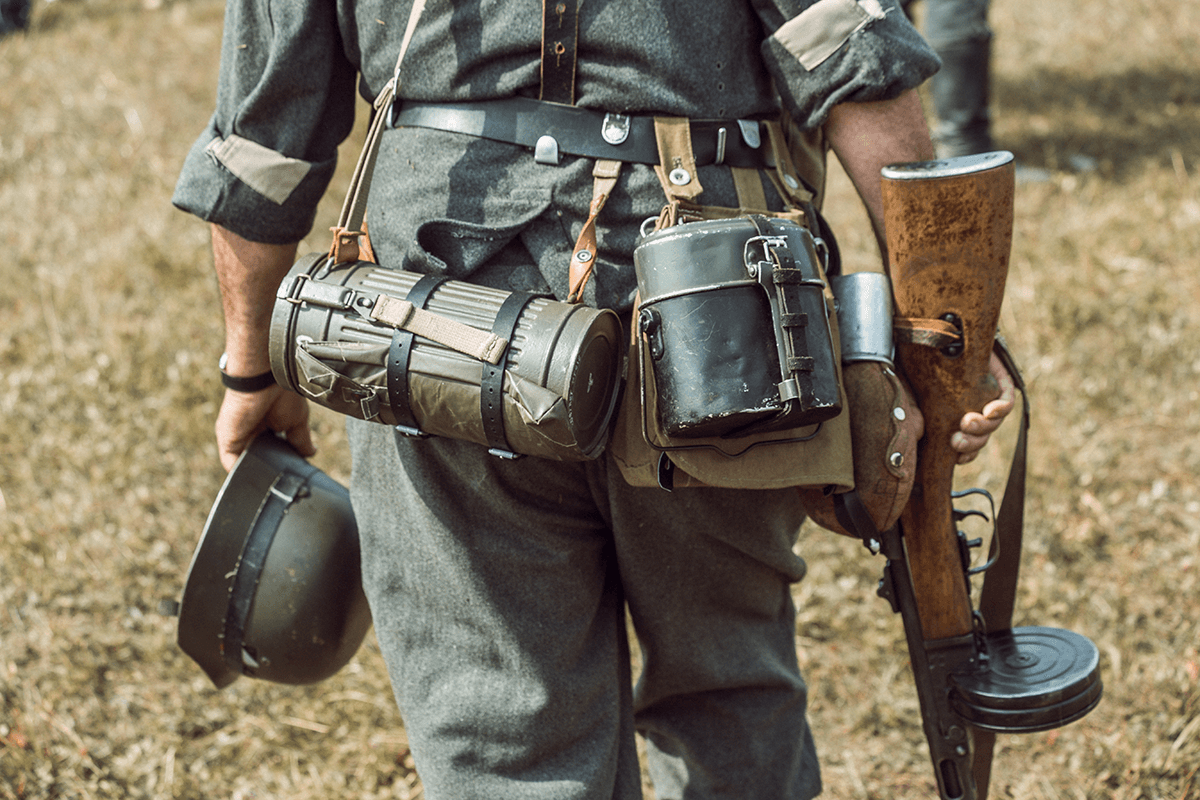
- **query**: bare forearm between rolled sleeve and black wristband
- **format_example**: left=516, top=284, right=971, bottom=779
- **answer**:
left=212, top=225, right=296, bottom=375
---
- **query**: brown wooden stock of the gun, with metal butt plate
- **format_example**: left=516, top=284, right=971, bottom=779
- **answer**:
left=883, top=152, right=1014, bottom=640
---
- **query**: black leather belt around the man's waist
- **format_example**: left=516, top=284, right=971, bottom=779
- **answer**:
left=391, top=97, right=774, bottom=169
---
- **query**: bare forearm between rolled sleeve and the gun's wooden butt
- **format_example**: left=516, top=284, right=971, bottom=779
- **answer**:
left=824, top=90, right=934, bottom=264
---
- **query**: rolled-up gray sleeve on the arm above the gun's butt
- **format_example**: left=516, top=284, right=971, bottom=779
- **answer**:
left=755, top=0, right=941, bottom=130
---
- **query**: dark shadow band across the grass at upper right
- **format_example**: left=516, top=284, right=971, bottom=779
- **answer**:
left=994, top=65, right=1200, bottom=180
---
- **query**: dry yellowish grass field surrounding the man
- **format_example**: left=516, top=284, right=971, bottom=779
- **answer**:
left=0, top=0, right=1200, bottom=800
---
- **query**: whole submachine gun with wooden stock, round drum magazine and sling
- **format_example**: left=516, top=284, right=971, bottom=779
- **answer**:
left=868, top=152, right=1102, bottom=800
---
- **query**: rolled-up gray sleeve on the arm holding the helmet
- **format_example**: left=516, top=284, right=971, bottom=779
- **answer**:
left=172, top=0, right=356, bottom=243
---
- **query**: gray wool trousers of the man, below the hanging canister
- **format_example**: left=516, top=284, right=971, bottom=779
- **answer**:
left=349, top=420, right=821, bottom=800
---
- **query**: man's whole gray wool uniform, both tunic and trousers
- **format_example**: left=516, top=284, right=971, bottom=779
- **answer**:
left=174, top=0, right=937, bottom=800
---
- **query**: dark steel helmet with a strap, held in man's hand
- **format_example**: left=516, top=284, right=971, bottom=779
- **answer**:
left=179, top=432, right=371, bottom=688
